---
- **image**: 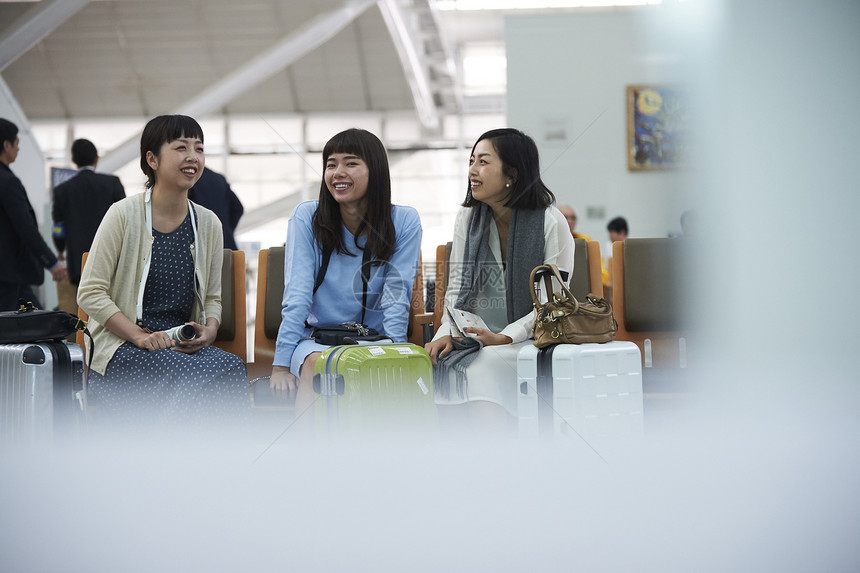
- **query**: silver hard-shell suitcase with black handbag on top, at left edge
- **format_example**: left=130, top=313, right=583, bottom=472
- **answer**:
left=0, top=341, right=87, bottom=445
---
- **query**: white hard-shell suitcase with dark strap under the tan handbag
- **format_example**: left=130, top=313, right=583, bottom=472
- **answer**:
left=517, top=340, right=643, bottom=440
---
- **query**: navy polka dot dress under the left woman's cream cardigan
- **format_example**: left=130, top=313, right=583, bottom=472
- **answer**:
left=89, top=210, right=250, bottom=424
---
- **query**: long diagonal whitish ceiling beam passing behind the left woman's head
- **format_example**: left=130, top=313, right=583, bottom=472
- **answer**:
left=99, top=0, right=375, bottom=172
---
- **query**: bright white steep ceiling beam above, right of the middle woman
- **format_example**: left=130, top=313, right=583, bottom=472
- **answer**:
left=378, top=0, right=440, bottom=130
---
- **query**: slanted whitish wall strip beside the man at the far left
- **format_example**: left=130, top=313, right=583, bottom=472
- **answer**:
left=0, top=76, right=57, bottom=308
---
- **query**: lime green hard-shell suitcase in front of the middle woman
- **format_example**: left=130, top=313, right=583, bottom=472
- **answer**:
left=314, top=343, right=438, bottom=434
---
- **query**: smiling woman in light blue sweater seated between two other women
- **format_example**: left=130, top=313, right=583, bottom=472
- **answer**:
left=270, top=129, right=421, bottom=412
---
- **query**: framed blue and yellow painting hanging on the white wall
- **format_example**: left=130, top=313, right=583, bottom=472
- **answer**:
left=627, top=85, right=687, bottom=171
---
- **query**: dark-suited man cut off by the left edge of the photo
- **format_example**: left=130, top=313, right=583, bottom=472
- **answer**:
left=0, top=118, right=66, bottom=310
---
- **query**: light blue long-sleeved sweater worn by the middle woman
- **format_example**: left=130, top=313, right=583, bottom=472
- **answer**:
left=274, top=201, right=421, bottom=366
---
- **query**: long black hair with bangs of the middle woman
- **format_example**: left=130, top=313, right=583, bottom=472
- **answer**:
left=312, top=128, right=396, bottom=265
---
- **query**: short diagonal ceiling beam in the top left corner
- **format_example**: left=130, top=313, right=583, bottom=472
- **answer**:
left=0, top=0, right=90, bottom=72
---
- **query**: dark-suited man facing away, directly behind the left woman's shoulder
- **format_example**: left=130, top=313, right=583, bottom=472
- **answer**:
left=53, top=139, right=125, bottom=314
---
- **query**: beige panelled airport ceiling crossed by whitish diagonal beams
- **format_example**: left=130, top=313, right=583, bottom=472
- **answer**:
left=0, top=0, right=503, bottom=131
